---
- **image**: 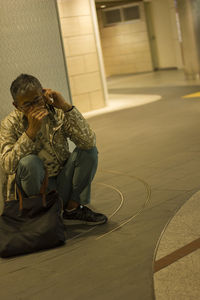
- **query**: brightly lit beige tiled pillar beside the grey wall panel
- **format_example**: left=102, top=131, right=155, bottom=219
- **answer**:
left=57, top=0, right=105, bottom=112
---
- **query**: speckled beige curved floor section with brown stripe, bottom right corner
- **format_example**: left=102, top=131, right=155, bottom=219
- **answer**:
left=154, top=192, right=200, bottom=300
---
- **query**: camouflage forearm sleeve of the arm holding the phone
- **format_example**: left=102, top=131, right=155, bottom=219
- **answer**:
left=64, top=107, right=96, bottom=149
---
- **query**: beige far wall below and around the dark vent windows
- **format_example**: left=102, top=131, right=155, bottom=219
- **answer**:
left=97, top=3, right=152, bottom=76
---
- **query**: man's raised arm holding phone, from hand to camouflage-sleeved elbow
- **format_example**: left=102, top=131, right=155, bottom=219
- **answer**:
left=44, top=89, right=96, bottom=149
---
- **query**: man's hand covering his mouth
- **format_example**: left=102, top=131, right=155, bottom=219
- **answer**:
left=26, top=106, right=48, bottom=140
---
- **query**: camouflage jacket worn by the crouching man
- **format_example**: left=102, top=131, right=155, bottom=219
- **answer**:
left=0, top=107, right=96, bottom=201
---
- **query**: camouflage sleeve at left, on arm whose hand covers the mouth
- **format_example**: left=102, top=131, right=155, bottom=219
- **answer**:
left=0, top=120, right=35, bottom=174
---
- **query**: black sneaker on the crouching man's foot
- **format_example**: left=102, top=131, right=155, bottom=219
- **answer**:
left=63, top=205, right=108, bottom=225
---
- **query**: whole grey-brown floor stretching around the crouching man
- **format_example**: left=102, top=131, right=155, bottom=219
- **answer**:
left=0, top=71, right=200, bottom=300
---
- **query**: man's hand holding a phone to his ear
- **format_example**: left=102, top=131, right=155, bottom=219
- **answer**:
left=42, top=89, right=72, bottom=111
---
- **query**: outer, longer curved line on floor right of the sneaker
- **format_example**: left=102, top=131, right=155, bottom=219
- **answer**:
left=95, top=170, right=151, bottom=240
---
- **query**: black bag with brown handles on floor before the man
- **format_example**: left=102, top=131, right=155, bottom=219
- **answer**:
left=0, top=171, right=66, bottom=257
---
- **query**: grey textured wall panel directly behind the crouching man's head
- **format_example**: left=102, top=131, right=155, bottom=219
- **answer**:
left=0, top=0, right=71, bottom=119
